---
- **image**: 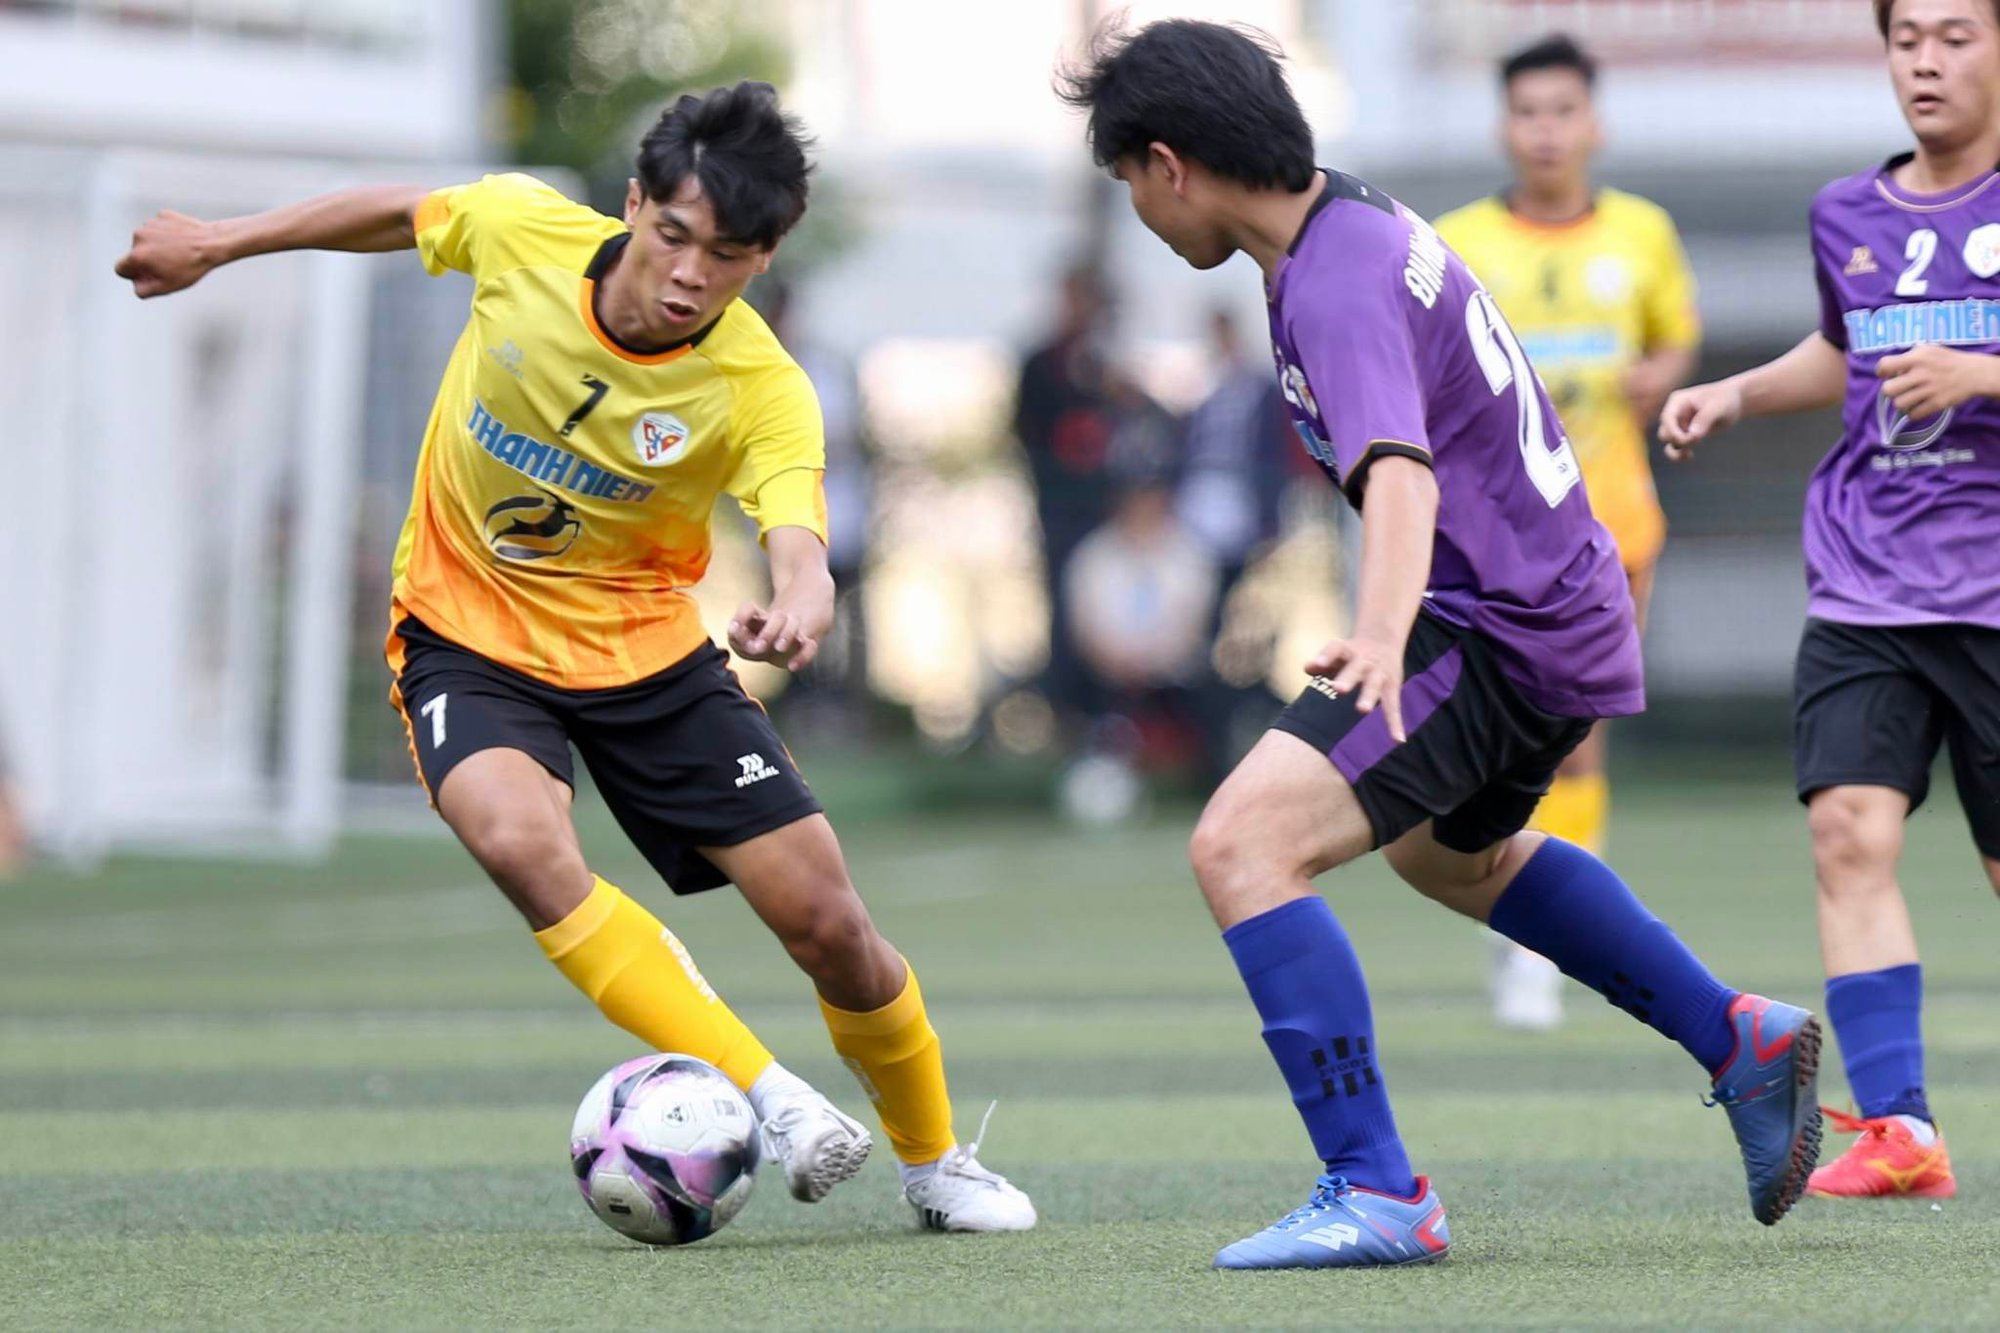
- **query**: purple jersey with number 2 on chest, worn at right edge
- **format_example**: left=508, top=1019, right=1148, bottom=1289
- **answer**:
left=1806, top=162, right=2000, bottom=628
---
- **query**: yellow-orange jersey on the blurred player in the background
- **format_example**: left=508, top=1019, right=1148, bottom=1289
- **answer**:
left=1438, top=188, right=1702, bottom=568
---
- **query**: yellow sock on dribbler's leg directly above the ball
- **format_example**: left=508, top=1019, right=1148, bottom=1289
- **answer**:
left=534, top=879, right=772, bottom=1091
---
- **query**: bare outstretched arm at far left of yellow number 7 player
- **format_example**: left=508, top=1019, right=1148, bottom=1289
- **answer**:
left=116, top=184, right=430, bottom=298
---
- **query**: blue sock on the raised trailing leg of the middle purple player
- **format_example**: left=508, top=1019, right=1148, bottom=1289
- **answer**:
left=1488, top=839, right=1736, bottom=1073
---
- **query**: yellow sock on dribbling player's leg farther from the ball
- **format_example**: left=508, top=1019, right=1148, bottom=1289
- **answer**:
left=820, top=961, right=958, bottom=1165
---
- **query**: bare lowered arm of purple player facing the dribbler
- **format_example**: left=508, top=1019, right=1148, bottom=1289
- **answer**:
left=1306, top=454, right=1438, bottom=743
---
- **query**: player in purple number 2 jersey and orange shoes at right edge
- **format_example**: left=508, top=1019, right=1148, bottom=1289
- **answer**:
left=1660, top=0, right=2000, bottom=1199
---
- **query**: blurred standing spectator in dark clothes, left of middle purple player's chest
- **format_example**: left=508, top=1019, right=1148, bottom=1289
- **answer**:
left=1014, top=264, right=1118, bottom=713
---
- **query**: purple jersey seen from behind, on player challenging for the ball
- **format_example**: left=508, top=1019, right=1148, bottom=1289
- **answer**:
left=1270, top=172, right=1646, bottom=717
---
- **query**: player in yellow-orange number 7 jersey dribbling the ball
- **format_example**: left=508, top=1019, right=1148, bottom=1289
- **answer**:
left=118, top=84, right=1036, bottom=1231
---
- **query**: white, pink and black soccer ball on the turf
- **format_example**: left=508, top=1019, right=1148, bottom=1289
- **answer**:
left=570, top=1055, right=762, bottom=1245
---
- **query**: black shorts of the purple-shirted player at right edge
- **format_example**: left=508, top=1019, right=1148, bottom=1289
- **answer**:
left=1792, top=620, right=2000, bottom=859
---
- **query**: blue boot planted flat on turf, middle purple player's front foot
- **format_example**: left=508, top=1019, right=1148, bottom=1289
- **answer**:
left=1216, top=1175, right=1452, bottom=1269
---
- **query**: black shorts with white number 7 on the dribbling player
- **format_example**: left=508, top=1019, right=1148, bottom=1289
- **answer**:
left=390, top=618, right=820, bottom=893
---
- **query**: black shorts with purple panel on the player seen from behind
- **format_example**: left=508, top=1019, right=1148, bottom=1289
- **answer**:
left=1274, top=614, right=1594, bottom=853
